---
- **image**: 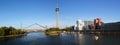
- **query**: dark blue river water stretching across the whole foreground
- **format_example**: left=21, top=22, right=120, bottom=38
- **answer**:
left=0, top=32, right=120, bottom=45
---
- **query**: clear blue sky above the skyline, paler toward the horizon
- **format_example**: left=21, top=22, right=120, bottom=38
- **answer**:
left=0, top=0, right=120, bottom=28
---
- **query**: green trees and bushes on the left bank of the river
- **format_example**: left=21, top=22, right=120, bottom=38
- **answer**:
left=0, top=26, right=27, bottom=36
